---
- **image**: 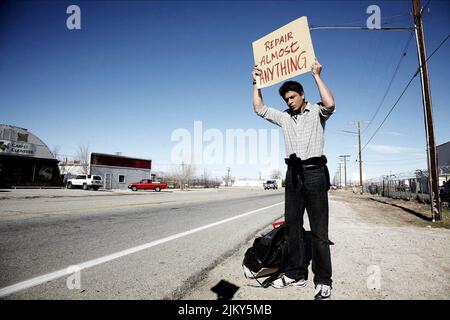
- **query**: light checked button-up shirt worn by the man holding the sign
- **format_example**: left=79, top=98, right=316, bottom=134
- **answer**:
left=257, top=102, right=335, bottom=160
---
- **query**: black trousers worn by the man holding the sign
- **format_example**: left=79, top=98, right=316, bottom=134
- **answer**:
left=285, top=159, right=332, bottom=286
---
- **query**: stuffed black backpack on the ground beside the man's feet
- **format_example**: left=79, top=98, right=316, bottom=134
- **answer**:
left=242, top=224, right=287, bottom=288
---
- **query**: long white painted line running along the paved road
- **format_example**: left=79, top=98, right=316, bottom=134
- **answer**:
left=0, top=201, right=284, bottom=297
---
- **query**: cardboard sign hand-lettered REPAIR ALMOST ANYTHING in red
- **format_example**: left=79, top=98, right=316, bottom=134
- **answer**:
left=252, top=17, right=315, bottom=88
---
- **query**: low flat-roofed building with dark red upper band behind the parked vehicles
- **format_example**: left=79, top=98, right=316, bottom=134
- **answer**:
left=89, top=153, right=152, bottom=189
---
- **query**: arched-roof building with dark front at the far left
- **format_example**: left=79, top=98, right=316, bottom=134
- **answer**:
left=0, top=124, right=62, bottom=188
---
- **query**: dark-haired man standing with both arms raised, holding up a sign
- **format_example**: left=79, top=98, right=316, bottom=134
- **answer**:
left=252, top=18, right=335, bottom=300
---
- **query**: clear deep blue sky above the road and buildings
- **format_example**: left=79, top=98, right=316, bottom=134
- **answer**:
left=0, top=0, right=450, bottom=178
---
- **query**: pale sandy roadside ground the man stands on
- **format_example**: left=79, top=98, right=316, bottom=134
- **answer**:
left=184, top=190, right=450, bottom=300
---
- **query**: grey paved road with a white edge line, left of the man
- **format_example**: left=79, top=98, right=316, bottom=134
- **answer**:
left=0, top=190, right=284, bottom=299
